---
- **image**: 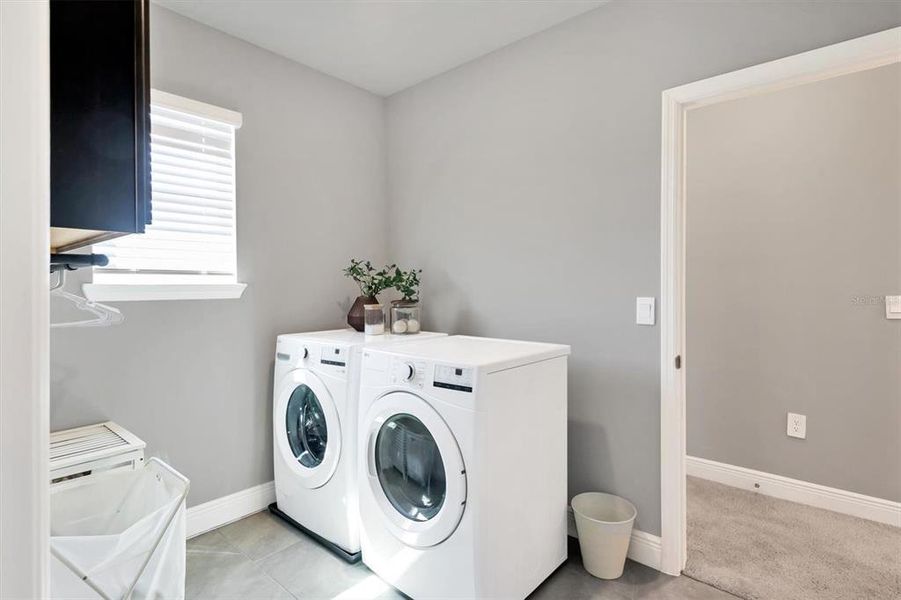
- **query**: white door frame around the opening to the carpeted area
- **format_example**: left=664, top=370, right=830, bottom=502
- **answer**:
left=660, top=27, right=901, bottom=575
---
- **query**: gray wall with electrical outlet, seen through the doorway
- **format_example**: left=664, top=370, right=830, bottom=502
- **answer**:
left=686, top=64, right=901, bottom=500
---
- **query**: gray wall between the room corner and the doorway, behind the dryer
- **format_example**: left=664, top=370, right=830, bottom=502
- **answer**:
left=387, top=2, right=901, bottom=534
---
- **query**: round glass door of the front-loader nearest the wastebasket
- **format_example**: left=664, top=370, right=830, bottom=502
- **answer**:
left=366, top=392, right=466, bottom=548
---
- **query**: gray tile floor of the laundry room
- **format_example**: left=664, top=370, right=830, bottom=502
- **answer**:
left=186, top=512, right=735, bottom=600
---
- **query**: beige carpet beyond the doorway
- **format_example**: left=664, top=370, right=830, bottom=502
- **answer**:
left=685, top=477, right=901, bottom=600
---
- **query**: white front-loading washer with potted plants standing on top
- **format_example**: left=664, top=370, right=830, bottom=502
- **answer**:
left=270, top=329, right=444, bottom=561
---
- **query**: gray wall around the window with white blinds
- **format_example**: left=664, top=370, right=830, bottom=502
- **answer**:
left=51, top=6, right=386, bottom=504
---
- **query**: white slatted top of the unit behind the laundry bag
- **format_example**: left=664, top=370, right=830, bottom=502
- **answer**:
left=50, top=421, right=146, bottom=481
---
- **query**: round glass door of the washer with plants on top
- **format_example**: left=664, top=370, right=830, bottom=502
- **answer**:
left=274, top=369, right=341, bottom=488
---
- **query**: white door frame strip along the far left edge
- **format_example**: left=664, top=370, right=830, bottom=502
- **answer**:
left=0, top=0, right=50, bottom=598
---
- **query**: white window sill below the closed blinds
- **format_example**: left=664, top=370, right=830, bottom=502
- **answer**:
left=82, top=283, right=247, bottom=302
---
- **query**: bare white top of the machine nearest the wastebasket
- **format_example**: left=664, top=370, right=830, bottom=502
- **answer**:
left=374, top=335, right=570, bottom=373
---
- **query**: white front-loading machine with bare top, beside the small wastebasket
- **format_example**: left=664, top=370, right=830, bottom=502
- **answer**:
left=359, top=336, right=569, bottom=600
